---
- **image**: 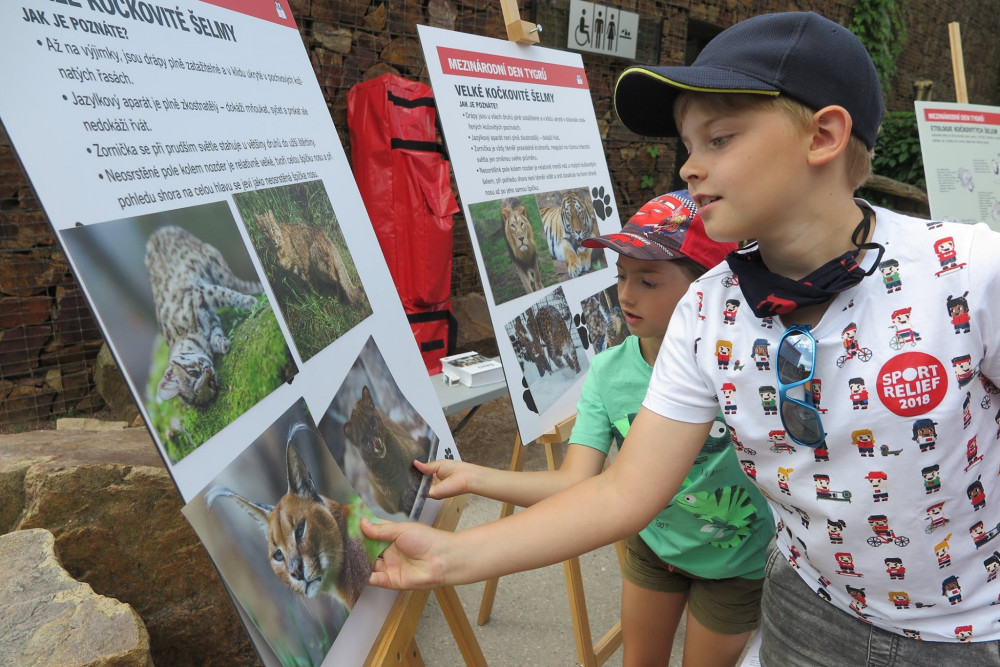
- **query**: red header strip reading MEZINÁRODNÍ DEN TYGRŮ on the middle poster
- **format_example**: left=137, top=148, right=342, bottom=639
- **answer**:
left=437, top=46, right=588, bottom=88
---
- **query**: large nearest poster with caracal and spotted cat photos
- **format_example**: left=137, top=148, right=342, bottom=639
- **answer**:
left=0, top=0, right=458, bottom=665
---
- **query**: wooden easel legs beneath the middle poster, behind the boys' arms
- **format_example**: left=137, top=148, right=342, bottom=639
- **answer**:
left=478, top=416, right=625, bottom=667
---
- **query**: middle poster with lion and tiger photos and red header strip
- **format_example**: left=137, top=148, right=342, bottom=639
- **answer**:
left=418, top=26, right=628, bottom=443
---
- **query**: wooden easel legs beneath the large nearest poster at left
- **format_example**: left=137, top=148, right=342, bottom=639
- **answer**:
left=365, top=496, right=487, bottom=667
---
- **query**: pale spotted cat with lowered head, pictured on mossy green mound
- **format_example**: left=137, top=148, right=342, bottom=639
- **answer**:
left=146, top=226, right=263, bottom=406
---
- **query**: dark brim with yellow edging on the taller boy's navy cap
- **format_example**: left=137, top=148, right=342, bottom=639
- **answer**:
left=614, top=66, right=781, bottom=137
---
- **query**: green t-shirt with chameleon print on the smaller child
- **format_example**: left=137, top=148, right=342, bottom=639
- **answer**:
left=569, top=336, right=774, bottom=579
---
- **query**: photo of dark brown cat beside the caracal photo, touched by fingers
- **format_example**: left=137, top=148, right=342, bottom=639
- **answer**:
left=319, top=339, right=439, bottom=520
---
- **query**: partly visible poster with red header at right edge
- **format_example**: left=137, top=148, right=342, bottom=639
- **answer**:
left=916, top=102, right=1000, bottom=231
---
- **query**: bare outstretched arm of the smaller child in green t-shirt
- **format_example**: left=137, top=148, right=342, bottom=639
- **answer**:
left=414, top=445, right=607, bottom=507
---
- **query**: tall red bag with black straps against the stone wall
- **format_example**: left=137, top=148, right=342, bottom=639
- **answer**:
left=347, top=74, right=458, bottom=373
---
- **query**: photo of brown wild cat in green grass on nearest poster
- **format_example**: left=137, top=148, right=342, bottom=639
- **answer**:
left=233, top=181, right=372, bottom=361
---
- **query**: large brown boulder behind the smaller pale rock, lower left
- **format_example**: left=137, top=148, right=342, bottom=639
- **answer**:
left=0, top=429, right=260, bottom=665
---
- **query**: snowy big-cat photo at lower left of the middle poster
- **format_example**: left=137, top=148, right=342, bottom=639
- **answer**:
left=505, top=287, right=589, bottom=414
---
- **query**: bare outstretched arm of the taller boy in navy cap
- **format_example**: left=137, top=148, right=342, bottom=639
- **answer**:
left=362, top=408, right=710, bottom=589
